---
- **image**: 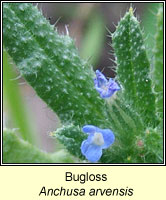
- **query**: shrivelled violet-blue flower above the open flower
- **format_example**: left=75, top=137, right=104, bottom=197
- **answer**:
left=94, top=70, right=120, bottom=99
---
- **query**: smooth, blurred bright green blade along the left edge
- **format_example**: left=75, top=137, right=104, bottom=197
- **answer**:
left=3, top=51, right=35, bottom=143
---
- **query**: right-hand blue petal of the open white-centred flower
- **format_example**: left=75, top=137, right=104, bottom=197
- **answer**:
left=101, top=129, right=115, bottom=149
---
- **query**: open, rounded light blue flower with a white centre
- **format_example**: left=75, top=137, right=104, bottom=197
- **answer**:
left=81, top=125, right=115, bottom=162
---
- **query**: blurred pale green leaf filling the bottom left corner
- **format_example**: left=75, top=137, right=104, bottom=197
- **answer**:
left=3, top=129, right=73, bottom=163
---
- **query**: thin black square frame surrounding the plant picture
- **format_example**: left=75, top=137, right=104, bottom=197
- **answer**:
left=0, top=1, right=166, bottom=166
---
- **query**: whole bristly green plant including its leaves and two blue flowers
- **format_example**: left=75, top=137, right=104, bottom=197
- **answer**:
left=3, top=3, right=163, bottom=163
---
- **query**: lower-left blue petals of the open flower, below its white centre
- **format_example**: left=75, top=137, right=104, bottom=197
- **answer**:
left=81, top=140, right=102, bottom=162
